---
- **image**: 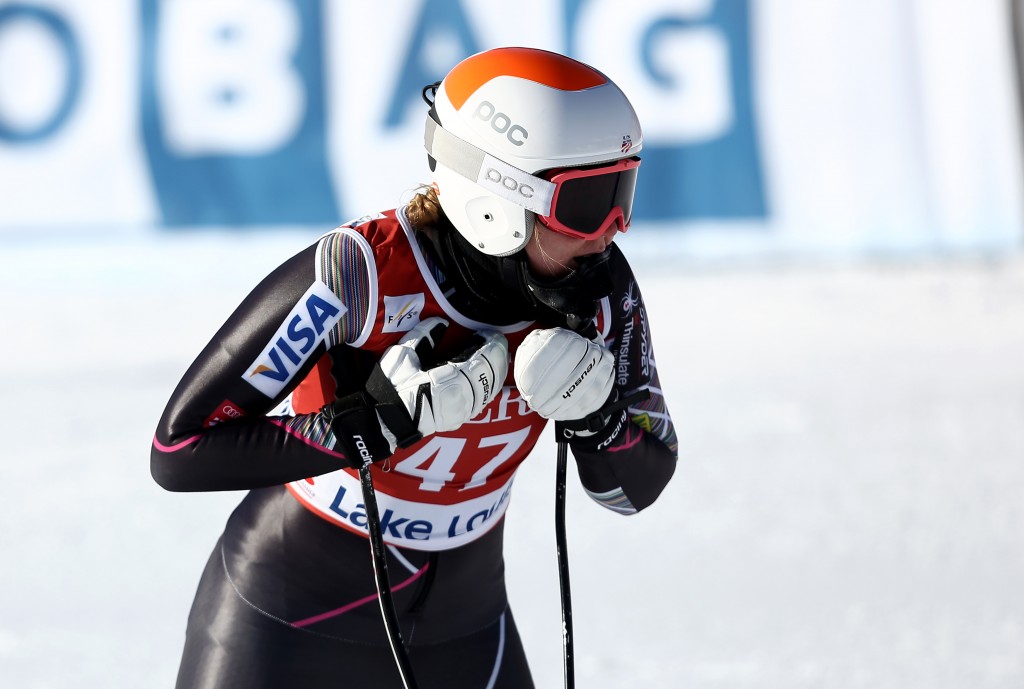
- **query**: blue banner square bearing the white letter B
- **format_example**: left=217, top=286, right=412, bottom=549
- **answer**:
left=140, top=0, right=341, bottom=225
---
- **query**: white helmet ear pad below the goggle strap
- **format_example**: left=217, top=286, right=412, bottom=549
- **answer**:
left=432, top=162, right=537, bottom=256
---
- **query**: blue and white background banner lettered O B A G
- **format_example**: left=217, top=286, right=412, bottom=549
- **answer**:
left=0, top=0, right=766, bottom=227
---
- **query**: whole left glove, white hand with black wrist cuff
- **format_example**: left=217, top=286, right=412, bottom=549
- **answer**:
left=323, top=317, right=508, bottom=466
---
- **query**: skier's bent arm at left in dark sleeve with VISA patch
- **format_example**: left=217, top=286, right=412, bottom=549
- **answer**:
left=151, top=233, right=367, bottom=490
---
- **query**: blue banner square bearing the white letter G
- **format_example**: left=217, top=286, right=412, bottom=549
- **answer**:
left=565, top=0, right=766, bottom=221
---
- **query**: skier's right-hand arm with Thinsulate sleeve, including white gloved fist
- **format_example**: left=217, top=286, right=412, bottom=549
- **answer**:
left=515, top=245, right=677, bottom=514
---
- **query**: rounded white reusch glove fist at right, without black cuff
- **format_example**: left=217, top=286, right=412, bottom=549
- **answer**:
left=513, top=328, right=615, bottom=421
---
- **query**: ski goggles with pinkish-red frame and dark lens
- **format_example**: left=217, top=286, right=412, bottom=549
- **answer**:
left=538, top=158, right=640, bottom=240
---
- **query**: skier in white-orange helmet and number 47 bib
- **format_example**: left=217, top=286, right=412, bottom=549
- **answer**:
left=152, top=48, right=676, bottom=689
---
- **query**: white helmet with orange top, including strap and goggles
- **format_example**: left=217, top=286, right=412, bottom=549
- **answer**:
left=424, top=48, right=643, bottom=256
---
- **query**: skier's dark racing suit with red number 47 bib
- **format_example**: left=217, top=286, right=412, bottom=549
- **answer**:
left=152, top=205, right=676, bottom=689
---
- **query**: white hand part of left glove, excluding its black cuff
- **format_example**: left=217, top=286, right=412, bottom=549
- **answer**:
left=380, top=317, right=509, bottom=440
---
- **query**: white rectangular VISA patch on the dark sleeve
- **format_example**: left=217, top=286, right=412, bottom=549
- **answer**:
left=242, top=281, right=348, bottom=399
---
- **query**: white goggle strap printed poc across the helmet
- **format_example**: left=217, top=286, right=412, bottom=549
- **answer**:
left=423, top=117, right=555, bottom=215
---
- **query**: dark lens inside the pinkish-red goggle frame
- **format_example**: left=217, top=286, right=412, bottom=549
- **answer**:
left=554, top=168, right=639, bottom=234
